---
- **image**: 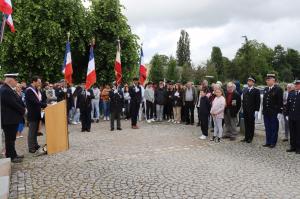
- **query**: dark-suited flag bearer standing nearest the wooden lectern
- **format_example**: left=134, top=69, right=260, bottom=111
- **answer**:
left=77, top=83, right=94, bottom=132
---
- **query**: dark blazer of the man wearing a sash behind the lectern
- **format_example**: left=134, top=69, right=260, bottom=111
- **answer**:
left=25, top=86, right=47, bottom=122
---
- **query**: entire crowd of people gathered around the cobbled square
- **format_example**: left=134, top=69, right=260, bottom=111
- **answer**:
left=0, top=74, right=300, bottom=162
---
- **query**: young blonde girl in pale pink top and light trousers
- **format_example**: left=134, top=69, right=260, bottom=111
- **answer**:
left=210, top=88, right=226, bottom=142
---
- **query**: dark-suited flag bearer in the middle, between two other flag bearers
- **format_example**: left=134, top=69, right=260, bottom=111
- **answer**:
left=109, top=85, right=124, bottom=131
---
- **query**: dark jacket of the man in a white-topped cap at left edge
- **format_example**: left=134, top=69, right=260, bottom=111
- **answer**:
left=0, top=84, right=25, bottom=125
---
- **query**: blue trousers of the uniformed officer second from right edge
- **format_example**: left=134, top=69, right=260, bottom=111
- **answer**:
left=264, top=115, right=279, bottom=145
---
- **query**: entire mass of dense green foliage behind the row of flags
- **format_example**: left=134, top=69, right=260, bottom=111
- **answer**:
left=0, top=0, right=138, bottom=83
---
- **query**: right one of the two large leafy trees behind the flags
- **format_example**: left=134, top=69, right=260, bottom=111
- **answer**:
left=88, top=0, right=140, bottom=82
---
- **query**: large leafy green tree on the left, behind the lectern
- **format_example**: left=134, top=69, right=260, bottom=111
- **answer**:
left=0, top=0, right=87, bottom=81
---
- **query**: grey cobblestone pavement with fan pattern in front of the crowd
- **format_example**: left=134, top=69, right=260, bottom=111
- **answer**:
left=10, top=121, right=300, bottom=199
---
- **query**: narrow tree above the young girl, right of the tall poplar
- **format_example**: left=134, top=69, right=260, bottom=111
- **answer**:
left=211, top=47, right=224, bottom=80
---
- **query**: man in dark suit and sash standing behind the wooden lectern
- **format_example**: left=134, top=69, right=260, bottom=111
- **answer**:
left=25, top=76, right=47, bottom=153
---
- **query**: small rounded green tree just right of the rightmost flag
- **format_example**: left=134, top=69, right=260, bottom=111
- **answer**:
left=148, top=54, right=166, bottom=83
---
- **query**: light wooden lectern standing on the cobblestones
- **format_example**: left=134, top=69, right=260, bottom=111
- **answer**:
left=45, top=100, right=69, bottom=154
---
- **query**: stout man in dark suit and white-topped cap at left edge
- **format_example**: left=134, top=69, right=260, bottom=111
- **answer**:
left=0, top=74, right=25, bottom=163
